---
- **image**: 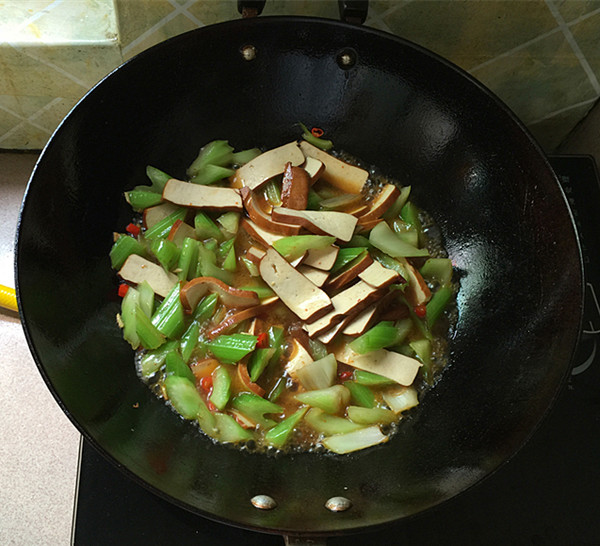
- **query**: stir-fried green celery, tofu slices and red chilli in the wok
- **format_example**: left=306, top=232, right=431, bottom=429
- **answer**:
left=110, top=127, right=454, bottom=453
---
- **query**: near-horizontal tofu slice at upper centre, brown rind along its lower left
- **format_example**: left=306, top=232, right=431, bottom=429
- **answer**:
left=271, top=207, right=358, bottom=241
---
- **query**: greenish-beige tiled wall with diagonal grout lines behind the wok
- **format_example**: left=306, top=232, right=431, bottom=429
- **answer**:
left=0, top=0, right=600, bottom=151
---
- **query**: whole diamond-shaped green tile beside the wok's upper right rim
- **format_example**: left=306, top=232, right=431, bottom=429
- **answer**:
left=472, top=32, right=596, bottom=123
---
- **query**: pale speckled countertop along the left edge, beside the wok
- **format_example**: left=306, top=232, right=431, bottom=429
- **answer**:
left=0, top=153, right=80, bottom=546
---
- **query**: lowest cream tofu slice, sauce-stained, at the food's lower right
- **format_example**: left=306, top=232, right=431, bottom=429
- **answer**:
left=335, top=346, right=422, bottom=387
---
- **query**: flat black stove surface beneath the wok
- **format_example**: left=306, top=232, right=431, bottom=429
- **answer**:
left=72, top=156, right=600, bottom=546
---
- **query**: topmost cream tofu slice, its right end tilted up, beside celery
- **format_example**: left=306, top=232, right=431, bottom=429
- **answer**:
left=232, top=141, right=304, bottom=190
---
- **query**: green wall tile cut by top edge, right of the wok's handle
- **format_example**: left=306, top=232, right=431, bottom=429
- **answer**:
left=373, top=0, right=557, bottom=69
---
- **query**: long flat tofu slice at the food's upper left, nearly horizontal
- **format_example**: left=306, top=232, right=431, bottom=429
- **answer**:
left=163, top=178, right=244, bottom=212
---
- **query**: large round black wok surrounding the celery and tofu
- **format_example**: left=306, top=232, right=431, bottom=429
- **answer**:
left=16, top=17, right=583, bottom=535
